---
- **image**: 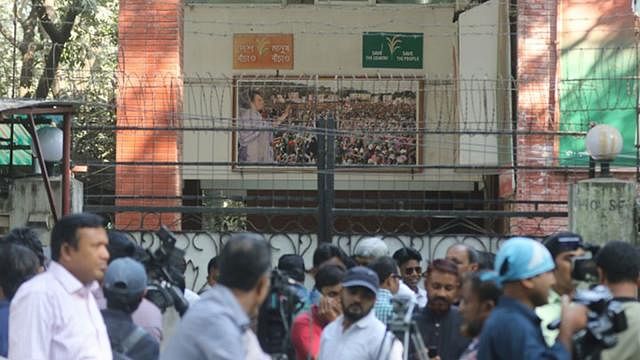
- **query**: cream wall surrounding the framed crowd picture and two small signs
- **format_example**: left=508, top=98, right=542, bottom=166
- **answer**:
left=183, top=4, right=488, bottom=191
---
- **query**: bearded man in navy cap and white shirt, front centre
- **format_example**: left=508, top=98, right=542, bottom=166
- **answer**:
left=318, top=266, right=402, bottom=360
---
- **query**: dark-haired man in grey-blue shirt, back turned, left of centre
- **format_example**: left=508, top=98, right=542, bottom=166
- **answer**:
left=161, top=233, right=271, bottom=360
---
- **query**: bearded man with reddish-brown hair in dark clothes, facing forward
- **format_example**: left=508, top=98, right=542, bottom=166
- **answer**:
left=415, top=259, right=470, bottom=360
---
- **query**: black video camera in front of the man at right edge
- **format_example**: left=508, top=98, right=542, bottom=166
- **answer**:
left=573, top=285, right=627, bottom=359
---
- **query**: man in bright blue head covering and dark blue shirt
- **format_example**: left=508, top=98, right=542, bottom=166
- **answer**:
left=478, top=237, right=586, bottom=360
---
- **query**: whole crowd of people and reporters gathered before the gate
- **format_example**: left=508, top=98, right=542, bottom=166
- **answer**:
left=0, top=213, right=640, bottom=360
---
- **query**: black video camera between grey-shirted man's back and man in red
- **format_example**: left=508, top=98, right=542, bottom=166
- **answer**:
left=258, top=269, right=304, bottom=359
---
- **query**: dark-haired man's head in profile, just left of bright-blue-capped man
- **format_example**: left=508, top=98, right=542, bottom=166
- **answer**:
left=460, top=272, right=502, bottom=360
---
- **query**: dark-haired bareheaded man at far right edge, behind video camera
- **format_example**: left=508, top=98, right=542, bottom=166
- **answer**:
left=596, top=241, right=640, bottom=360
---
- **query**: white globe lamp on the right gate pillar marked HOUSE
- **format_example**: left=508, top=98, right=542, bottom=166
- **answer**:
left=585, top=125, right=622, bottom=177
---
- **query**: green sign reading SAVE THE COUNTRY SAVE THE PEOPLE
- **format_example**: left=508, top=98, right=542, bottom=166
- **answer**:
left=362, top=32, right=423, bottom=69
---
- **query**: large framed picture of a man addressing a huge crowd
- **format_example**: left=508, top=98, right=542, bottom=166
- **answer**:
left=233, top=78, right=423, bottom=168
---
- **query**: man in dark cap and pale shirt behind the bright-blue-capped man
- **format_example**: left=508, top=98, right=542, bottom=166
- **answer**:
left=536, top=232, right=584, bottom=346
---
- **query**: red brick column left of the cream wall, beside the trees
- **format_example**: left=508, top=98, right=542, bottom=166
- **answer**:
left=116, top=0, right=183, bottom=230
